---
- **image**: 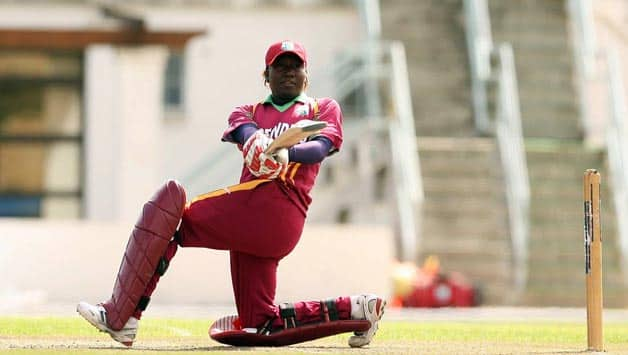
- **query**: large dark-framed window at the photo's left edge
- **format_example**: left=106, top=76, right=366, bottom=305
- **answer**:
left=0, top=50, right=83, bottom=218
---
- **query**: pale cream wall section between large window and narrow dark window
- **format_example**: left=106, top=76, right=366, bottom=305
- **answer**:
left=85, top=46, right=167, bottom=220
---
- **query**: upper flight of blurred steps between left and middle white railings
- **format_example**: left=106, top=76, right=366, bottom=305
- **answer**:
left=381, top=0, right=475, bottom=137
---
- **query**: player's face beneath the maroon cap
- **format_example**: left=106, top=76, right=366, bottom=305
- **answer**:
left=268, top=53, right=307, bottom=101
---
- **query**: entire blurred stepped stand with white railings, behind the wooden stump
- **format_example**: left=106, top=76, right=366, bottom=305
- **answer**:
left=381, top=0, right=628, bottom=307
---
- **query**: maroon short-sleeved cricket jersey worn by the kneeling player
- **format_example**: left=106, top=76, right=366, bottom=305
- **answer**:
left=222, top=94, right=342, bottom=213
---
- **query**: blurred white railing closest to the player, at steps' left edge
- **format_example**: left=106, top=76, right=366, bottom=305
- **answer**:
left=334, top=41, right=424, bottom=262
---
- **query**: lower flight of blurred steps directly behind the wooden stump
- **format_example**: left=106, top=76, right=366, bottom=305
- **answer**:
left=525, top=140, right=628, bottom=307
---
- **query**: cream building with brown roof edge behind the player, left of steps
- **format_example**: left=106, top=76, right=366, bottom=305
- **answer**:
left=0, top=1, right=361, bottom=220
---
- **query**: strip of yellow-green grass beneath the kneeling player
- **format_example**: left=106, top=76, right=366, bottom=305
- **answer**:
left=0, top=317, right=628, bottom=354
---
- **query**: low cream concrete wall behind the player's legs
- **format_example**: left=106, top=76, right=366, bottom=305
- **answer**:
left=0, top=219, right=393, bottom=311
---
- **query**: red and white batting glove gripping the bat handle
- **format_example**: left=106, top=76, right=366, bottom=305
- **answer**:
left=242, top=129, right=288, bottom=179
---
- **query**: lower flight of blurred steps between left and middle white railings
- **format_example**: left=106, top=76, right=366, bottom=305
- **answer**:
left=418, top=136, right=512, bottom=304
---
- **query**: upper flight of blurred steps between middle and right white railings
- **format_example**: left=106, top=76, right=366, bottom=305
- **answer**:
left=488, top=0, right=582, bottom=139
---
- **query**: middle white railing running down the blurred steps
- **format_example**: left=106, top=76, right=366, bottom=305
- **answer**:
left=464, top=0, right=530, bottom=296
